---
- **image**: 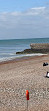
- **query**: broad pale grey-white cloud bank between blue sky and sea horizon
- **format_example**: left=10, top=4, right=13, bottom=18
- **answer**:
left=0, top=7, right=49, bottom=38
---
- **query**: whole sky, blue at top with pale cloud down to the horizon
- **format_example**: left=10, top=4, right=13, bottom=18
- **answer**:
left=0, top=0, right=49, bottom=39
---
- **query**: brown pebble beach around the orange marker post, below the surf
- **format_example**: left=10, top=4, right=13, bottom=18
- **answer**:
left=0, top=55, right=49, bottom=111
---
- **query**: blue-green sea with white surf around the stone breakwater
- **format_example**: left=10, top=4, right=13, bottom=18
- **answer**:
left=0, top=38, right=49, bottom=62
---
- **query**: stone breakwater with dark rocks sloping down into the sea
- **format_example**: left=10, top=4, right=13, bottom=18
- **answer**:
left=16, top=43, right=49, bottom=54
